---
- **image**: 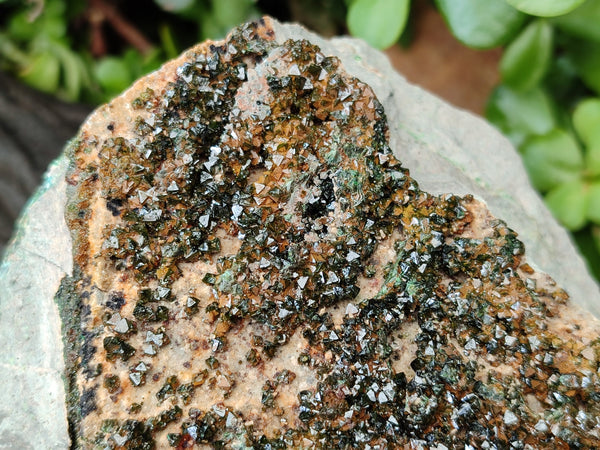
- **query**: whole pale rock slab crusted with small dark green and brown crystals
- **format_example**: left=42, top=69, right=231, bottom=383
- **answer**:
left=0, top=15, right=600, bottom=449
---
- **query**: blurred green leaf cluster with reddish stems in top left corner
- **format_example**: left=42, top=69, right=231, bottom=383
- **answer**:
left=0, top=0, right=258, bottom=104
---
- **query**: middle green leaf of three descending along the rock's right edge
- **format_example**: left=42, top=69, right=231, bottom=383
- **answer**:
left=522, top=128, right=583, bottom=192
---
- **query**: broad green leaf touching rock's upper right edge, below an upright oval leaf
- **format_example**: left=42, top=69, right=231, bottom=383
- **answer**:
left=486, top=85, right=556, bottom=147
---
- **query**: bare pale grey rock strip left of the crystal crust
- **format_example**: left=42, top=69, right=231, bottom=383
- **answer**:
left=0, top=156, right=73, bottom=449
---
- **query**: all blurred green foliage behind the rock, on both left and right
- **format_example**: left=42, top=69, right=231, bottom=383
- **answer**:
left=0, top=0, right=600, bottom=279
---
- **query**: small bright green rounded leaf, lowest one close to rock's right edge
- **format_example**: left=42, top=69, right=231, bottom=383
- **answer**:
left=545, top=180, right=589, bottom=231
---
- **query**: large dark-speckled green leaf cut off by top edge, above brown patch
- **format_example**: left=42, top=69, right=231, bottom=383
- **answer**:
left=435, top=0, right=525, bottom=48
